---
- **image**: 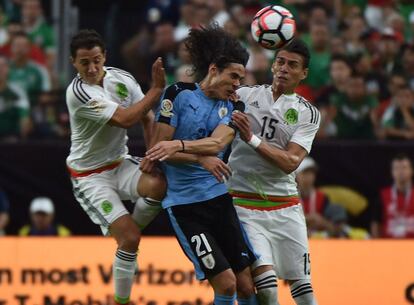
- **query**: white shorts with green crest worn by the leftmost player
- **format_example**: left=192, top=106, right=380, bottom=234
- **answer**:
left=71, top=157, right=141, bottom=235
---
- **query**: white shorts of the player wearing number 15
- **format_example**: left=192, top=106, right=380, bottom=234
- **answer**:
left=235, top=204, right=310, bottom=280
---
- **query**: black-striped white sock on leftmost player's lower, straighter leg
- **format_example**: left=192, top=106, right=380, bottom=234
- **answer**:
left=112, top=249, right=137, bottom=304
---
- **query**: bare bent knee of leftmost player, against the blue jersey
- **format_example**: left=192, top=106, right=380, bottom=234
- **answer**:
left=138, top=172, right=167, bottom=201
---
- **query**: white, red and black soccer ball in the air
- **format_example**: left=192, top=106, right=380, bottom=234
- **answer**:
left=251, top=5, right=296, bottom=50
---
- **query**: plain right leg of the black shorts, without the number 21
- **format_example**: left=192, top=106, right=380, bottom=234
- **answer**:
left=216, top=194, right=256, bottom=272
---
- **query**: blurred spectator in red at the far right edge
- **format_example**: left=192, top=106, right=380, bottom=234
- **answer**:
left=371, top=154, right=414, bottom=238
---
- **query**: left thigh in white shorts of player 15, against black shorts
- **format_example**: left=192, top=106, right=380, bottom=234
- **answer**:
left=235, top=206, right=274, bottom=269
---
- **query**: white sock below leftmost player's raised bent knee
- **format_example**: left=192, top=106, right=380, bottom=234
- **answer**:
left=132, top=197, right=162, bottom=230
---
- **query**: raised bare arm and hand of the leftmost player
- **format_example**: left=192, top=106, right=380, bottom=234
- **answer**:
left=109, top=57, right=165, bottom=128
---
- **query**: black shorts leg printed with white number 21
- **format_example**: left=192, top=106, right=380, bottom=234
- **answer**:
left=167, top=204, right=230, bottom=280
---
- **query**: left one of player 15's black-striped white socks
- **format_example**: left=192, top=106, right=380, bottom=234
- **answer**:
left=253, top=270, right=279, bottom=305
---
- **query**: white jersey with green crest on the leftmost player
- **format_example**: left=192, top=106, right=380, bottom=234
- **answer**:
left=66, top=67, right=144, bottom=171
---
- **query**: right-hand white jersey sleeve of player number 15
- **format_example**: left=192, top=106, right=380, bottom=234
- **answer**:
left=290, top=105, right=321, bottom=153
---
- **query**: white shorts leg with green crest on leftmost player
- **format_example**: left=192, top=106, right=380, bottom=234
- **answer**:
left=72, top=170, right=128, bottom=235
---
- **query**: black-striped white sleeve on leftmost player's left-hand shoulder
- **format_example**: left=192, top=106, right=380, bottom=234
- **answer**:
left=66, top=79, right=118, bottom=125
